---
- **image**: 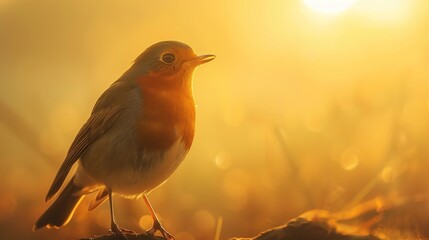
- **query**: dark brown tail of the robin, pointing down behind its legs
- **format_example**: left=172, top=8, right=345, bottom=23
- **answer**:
left=33, top=178, right=84, bottom=230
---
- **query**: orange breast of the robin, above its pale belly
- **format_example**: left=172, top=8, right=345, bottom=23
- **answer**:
left=136, top=74, right=195, bottom=151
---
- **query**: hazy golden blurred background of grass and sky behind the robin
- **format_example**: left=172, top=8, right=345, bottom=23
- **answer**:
left=0, top=0, right=429, bottom=240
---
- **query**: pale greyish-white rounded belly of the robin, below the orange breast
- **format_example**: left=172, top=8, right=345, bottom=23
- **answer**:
left=75, top=134, right=187, bottom=198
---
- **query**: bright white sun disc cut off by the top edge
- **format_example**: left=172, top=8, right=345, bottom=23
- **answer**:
left=303, top=0, right=357, bottom=14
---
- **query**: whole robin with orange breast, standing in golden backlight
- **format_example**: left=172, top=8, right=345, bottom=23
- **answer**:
left=34, top=41, right=215, bottom=239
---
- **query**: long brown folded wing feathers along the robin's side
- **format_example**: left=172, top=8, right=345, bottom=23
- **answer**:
left=45, top=107, right=120, bottom=201
